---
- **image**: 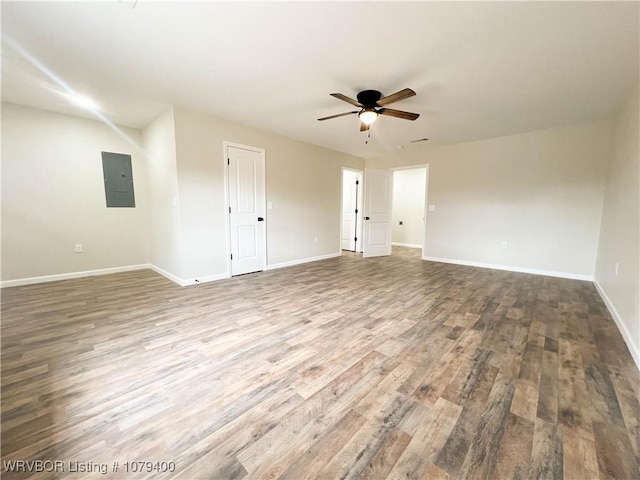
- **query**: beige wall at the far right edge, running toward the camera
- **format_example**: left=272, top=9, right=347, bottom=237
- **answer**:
left=595, top=85, right=640, bottom=368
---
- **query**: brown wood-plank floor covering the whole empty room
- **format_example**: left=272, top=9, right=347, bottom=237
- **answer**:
left=2, top=248, right=640, bottom=479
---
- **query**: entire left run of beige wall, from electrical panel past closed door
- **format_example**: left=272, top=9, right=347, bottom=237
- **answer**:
left=2, top=105, right=364, bottom=284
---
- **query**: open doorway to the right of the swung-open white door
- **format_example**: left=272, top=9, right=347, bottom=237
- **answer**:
left=391, top=165, right=429, bottom=258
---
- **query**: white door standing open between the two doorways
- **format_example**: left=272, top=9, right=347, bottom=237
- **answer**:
left=362, top=168, right=393, bottom=257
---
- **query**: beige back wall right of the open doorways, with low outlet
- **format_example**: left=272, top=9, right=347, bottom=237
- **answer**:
left=367, top=120, right=612, bottom=279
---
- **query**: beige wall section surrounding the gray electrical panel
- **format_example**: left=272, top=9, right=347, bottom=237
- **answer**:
left=2, top=103, right=149, bottom=285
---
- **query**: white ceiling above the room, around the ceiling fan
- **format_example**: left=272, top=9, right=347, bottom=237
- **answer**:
left=1, top=0, right=640, bottom=158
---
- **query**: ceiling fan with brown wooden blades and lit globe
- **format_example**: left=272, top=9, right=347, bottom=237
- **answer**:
left=318, top=88, right=420, bottom=132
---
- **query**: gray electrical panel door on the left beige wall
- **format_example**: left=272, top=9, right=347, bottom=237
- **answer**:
left=102, top=152, right=136, bottom=207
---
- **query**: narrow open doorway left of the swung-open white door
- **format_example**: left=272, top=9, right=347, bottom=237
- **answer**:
left=340, top=168, right=363, bottom=252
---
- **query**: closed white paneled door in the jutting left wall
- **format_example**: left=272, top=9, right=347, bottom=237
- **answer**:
left=227, top=146, right=266, bottom=275
